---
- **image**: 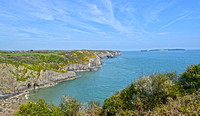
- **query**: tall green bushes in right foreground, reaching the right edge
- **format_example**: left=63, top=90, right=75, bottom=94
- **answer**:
left=102, top=64, right=200, bottom=116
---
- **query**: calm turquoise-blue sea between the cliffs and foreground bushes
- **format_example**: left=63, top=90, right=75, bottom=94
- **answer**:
left=29, top=50, right=200, bottom=105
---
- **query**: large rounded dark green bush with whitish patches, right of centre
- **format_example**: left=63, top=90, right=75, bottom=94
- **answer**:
left=103, top=73, right=179, bottom=115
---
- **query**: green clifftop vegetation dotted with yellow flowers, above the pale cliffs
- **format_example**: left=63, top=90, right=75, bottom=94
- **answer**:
left=0, top=50, right=99, bottom=81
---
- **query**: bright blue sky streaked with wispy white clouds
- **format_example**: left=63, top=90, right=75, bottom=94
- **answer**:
left=0, top=0, right=200, bottom=50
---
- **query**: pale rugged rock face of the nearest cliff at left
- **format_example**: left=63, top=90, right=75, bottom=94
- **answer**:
left=0, top=63, right=76, bottom=98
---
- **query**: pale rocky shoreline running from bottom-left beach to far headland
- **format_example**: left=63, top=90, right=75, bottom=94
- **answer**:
left=0, top=51, right=121, bottom=116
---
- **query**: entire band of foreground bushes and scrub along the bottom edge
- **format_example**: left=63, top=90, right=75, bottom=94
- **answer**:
left=15, top=64, right=200, bottom=116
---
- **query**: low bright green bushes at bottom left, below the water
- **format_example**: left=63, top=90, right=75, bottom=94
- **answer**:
left=14, top=97, right=82, bottom=116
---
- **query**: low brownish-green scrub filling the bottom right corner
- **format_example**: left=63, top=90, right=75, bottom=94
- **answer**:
left=151, top=91, right=200, bottom=116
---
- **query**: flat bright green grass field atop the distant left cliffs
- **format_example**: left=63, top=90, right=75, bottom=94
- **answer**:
left=0, top=52, right=58, bottom=56
